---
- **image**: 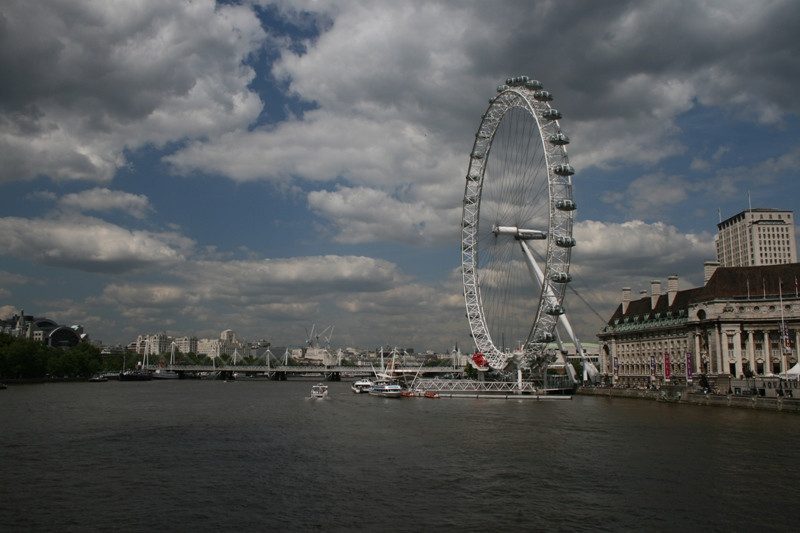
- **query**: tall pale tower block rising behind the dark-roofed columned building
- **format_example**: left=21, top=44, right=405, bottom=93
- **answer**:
left=715, top=208, right=797, bottom=267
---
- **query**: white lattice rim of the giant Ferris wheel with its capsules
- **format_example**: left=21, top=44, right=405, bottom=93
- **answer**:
left=461, top=76, right=575, bottom=369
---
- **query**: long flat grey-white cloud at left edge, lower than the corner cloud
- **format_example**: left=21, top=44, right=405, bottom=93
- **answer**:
left=0, top=217, right=193, bottom=274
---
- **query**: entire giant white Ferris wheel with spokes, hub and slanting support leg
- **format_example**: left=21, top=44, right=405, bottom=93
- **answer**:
left=461, top=76, right=580, bottom=370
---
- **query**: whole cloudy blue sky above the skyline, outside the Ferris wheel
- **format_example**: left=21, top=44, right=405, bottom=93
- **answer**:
left=0, top=0, right=800, bottom=350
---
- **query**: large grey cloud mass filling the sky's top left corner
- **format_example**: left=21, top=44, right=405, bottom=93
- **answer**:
left=0, top=0, right=265, bottom=181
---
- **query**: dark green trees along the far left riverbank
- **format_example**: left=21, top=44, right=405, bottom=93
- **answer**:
left=0, top=333, right=103, bottom=379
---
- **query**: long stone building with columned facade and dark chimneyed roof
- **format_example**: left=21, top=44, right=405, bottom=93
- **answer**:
left=598, top=262, right=800, bottom=387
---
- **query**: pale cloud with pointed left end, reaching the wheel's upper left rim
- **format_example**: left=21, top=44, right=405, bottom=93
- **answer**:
left=164, top=110, right=462, bottom=188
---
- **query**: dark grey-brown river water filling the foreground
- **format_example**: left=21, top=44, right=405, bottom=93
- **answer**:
left=0, top=380, right=800, bottom=532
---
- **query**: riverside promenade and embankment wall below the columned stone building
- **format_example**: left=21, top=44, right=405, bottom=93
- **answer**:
left=576, top=386, right=800, bottom=414
